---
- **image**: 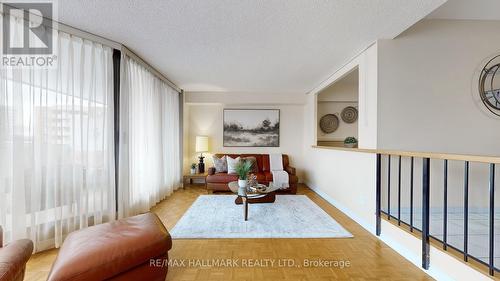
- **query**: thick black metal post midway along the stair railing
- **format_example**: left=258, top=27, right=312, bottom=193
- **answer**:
left=422, top=158, right=431, bottom=269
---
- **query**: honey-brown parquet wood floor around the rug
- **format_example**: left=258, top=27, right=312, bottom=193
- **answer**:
left=25, top=185, right=432, bottom=281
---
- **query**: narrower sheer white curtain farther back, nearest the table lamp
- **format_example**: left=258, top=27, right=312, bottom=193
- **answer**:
left=118, top=55, right=181, bottom=217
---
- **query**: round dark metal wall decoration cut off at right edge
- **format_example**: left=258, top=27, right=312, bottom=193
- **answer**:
left=479, top=55, right=500, bottom=116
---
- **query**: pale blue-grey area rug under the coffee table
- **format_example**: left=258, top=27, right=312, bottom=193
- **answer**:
left=170, top=195, right=352, bottom=239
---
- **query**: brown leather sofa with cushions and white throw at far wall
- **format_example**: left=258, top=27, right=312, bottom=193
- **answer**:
left=207, top=154, right=299, bottom=194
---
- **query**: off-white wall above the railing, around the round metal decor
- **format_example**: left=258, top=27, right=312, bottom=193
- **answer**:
left=378, top=20, right=500, bottom=156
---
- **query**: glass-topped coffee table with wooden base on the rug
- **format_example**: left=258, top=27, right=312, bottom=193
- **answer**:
left=228, top=181, right=279, bottom=221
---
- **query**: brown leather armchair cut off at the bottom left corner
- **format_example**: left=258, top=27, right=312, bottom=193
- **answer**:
left=0, top=227, right=33, bottom=281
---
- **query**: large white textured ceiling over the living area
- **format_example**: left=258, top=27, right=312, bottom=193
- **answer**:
left=59, top=0, right=445, bottom=93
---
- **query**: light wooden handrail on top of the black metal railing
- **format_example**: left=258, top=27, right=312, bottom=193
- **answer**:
left=312, top=145, right=500, bottom=164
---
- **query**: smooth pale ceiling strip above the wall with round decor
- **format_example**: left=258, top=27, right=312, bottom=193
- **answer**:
left=428, top=0, right=500, bottom=20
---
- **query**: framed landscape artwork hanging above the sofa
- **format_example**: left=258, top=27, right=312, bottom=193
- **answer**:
left=223, top=109, right=280, bottom=147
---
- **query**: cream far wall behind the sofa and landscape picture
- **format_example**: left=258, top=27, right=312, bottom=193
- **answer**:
left=185, top=92, right=305, bottom=180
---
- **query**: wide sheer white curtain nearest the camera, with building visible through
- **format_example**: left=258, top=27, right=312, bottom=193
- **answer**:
left=0, top=22, right=116, bottom=251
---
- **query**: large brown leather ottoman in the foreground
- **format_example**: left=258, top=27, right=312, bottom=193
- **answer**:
left=48, top=213, right=172, bottom=281
